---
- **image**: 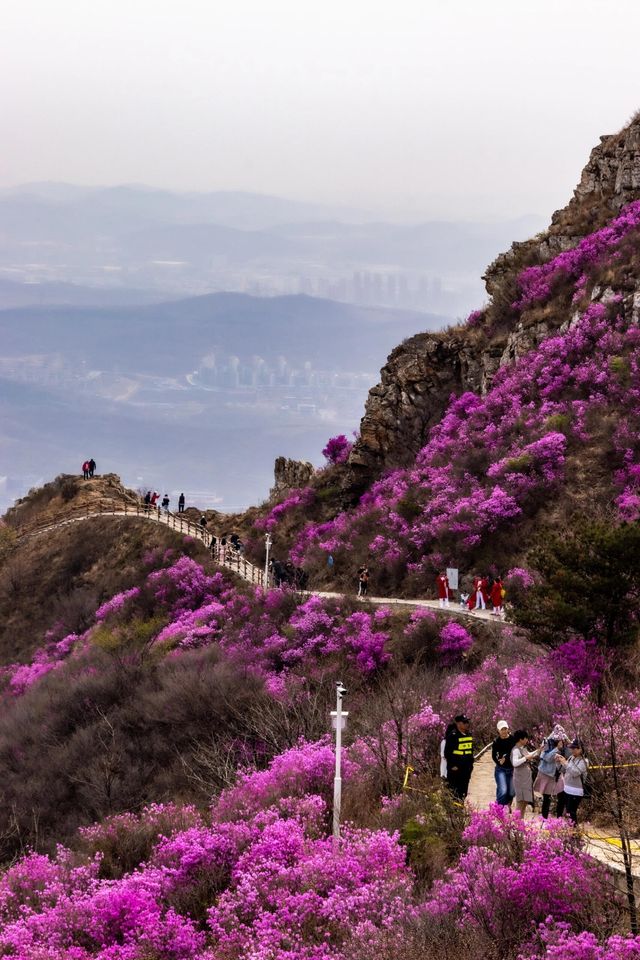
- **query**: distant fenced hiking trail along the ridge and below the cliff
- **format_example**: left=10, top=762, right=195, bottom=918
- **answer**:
left=19, top=501, right=505, bottom=624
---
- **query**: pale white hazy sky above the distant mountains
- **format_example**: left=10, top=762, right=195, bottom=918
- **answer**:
left=0, top=0, right=640, bottom=221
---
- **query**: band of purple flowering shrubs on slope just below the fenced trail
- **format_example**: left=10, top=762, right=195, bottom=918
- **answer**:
left=0, top=556, right=391, bottom=697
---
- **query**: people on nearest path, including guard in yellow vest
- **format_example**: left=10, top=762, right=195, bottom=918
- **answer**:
left=440, top=713, right=589, bottom=823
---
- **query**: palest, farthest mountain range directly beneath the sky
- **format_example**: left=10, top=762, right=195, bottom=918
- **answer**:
left=0, top=183, right=543, bottom=317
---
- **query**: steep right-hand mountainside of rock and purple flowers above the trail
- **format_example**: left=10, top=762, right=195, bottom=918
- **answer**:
left=251, top=119, right=640, bottom=594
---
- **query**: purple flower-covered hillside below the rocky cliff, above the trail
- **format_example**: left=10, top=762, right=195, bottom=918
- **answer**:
left=276, top=248, right=640, bottom=593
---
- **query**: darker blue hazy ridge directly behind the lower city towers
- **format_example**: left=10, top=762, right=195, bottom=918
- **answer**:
left=0, top=293, right=446, bottom=375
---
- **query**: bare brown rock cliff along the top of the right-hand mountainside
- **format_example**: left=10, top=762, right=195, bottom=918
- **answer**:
left=348, top=114, right=640, bottom=495
